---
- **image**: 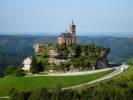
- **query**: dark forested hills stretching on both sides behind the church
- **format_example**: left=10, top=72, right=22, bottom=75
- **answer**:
left=0, top=35, right=133, bottom=69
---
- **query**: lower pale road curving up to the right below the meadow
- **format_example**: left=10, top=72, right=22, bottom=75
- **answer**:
left=62, top=65, right=128, bottom=90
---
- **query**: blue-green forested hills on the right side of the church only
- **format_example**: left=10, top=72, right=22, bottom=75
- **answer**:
left=78, top=36, right=133, bottom=62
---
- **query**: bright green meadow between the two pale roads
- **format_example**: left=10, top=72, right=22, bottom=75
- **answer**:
left=0, top=70, right=113, bottom=96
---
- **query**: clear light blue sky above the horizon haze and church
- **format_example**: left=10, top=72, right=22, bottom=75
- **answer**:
left=0, top=0, right=133, bottom=33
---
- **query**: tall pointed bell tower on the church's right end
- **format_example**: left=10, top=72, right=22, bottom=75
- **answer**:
left=69, top=20, right=76, bottom=43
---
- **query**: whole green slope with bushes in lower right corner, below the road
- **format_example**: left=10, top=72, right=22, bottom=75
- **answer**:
left=77, top=66, right=133, bottom=100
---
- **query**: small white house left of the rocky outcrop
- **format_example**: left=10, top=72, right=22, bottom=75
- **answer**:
left=22, top=57, right=32, bottom=71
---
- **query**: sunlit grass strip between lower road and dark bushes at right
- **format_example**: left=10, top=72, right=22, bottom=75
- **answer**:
left=78, top=66, right=133, bottom=91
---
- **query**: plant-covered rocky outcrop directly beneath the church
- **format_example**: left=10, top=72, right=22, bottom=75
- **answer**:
left=34, top=43, right=110, bottom=70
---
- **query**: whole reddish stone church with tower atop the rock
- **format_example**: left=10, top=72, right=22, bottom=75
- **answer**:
left=58, top=21, right=76, bottom=45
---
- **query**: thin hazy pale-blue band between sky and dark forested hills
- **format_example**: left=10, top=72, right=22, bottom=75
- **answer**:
left=0, top=32, right=133, bottom=36
